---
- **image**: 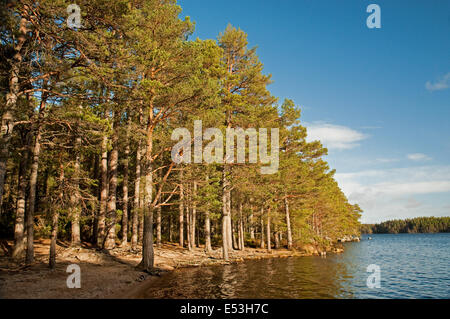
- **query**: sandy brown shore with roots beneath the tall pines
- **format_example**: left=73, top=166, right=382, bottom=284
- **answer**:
left=0, top=240, right=341, bottom=299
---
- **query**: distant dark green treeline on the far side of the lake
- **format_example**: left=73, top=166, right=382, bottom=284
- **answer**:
left=361, top=217, right=450, bottom=234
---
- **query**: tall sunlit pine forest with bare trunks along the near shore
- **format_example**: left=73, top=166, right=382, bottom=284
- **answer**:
left=0, top=0, right=360, bottom=271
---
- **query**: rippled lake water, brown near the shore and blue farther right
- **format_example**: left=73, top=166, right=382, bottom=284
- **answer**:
left=139, top=234, right=450, bottom=299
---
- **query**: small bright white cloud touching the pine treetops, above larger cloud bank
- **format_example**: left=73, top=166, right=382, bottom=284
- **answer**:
left=306, top=123, right=368, bottom=150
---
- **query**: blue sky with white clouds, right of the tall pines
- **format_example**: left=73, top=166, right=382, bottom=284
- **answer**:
left=179, top=0, right=450, bottom=222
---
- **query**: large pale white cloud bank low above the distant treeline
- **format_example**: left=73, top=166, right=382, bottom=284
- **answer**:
left=336, top=166, right=450, bottom=223
